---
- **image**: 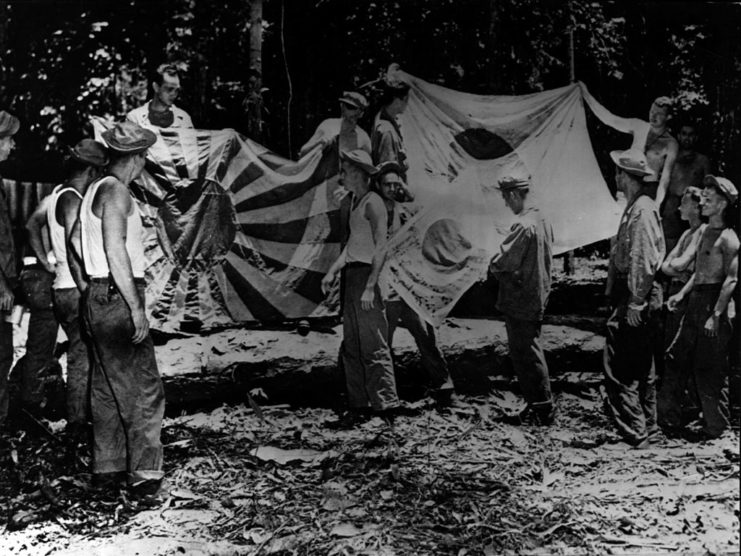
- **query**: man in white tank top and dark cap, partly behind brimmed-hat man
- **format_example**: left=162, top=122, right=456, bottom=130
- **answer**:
left=45, top=139, right=108, bottom=437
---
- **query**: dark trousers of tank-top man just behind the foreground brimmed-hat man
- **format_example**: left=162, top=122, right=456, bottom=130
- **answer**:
left=54, top=288, right=90, bottom=424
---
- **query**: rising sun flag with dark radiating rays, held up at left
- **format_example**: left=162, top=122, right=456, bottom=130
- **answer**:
left=94, top=118, right=340, bottom=331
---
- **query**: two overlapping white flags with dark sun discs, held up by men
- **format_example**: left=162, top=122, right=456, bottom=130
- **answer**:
left=386, top=72, right=621, bottom=325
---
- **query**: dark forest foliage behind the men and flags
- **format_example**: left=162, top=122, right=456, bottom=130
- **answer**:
left=0, top=0, right=741, bottom=188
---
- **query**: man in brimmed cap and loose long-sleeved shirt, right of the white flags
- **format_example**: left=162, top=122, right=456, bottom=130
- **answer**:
left=604, top=153, right=664, bottom=448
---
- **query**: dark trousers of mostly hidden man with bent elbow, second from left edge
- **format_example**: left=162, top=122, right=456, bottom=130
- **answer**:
left=13, top=265, right=59, bottom=410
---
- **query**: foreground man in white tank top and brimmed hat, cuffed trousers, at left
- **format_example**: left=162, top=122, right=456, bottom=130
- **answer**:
left=79, top=121, right=165, bottom=503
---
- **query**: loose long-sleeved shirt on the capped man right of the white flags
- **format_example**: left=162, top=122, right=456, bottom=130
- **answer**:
left=610, top=193, right=665, bottom=305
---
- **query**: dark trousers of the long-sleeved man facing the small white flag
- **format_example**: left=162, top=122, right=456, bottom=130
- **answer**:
left=504, top=315, right=553, bottom=414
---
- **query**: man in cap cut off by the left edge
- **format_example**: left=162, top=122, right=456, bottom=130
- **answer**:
left=0, top=110, right=20, bottom=427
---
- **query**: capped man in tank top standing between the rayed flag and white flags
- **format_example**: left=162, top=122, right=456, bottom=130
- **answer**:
left=322, top=149, right=399, bottom=426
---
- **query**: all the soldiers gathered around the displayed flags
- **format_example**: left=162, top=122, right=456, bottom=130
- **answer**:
left=0, top=60, right=739, bottom=504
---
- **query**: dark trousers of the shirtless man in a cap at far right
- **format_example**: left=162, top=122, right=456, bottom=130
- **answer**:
left=658, top=284, right=732, bottom=437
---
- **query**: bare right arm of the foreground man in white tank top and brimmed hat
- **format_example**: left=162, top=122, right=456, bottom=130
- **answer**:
left=98, top=182, right=149, bottom=344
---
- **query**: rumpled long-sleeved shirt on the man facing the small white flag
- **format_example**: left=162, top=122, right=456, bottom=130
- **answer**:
left=489, top=208, right=553, bottom=321
